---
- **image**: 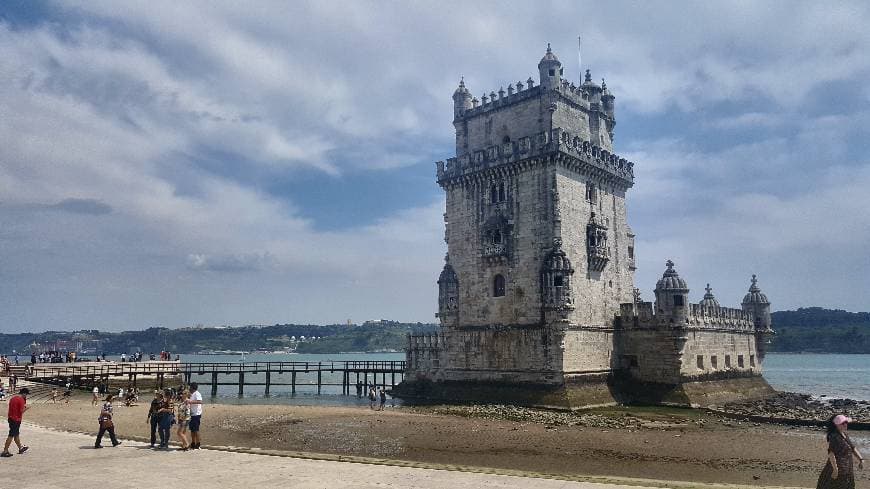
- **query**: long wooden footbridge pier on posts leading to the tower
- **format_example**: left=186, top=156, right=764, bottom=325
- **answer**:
left=27, top=360, right=405, bottom=396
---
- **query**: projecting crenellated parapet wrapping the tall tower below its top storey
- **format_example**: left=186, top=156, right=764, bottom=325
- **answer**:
left=436, top=128, right=634, bottom=188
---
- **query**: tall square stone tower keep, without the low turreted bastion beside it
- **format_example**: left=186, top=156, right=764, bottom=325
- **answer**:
left=400, top=46, right=634, bottom=406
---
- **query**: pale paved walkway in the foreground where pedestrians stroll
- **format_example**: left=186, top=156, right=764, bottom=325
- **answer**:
left=0, top=423, right=660, bottom=489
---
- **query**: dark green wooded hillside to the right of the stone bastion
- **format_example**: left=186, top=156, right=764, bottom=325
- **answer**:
left=770, top=307, right=870, bottom=353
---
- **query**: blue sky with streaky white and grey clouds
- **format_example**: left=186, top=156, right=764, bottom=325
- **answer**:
left=0, top=0, right=870, bottom=332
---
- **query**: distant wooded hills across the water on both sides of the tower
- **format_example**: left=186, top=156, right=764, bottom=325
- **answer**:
left=0, top=307, right=870, bottom=355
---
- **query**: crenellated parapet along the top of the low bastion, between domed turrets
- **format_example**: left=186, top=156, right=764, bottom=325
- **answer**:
left=620, top=302, right=755, bottom=331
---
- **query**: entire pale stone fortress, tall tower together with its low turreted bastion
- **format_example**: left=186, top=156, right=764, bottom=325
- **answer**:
left=395, top=46, right=772, bottom=408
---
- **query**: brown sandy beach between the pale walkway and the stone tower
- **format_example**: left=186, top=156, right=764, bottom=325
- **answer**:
left=17, top=394, right=870, bottom=487
